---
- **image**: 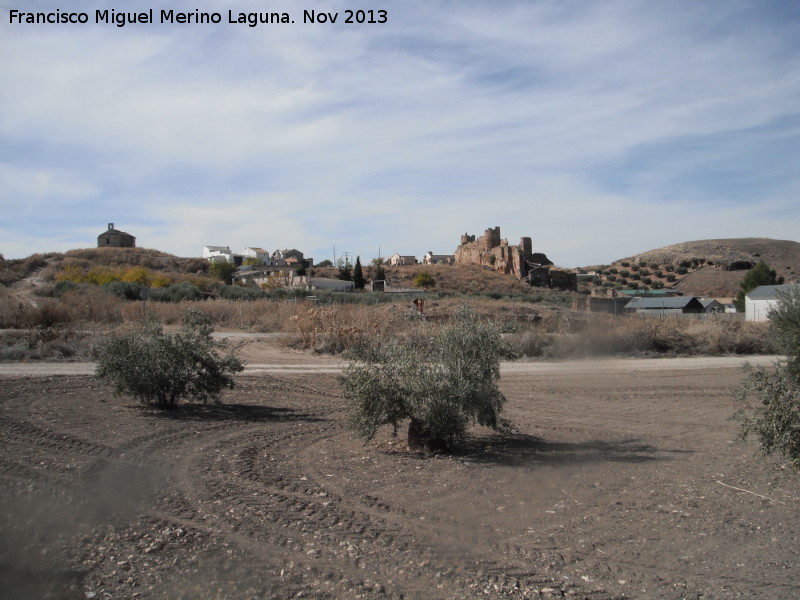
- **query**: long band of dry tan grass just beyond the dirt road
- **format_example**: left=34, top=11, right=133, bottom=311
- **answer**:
left=0, top=266, right=773, bottom=359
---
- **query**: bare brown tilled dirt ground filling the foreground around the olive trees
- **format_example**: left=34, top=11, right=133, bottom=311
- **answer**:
left=0, top=346, right=800, bottom=600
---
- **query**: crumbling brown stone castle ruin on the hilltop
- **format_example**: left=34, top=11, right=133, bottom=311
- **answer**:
left=454, top=227, right=578, bottom=290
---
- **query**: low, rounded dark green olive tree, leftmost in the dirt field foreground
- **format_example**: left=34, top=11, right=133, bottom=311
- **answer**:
left=96, top=309, right=244, bottom=409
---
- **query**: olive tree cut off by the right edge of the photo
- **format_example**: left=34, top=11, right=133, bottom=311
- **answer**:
left=734, top=288, right=800, bottom=468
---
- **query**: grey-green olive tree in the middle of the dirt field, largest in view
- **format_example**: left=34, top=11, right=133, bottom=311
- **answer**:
left=339, top=307, right=507, bottom=450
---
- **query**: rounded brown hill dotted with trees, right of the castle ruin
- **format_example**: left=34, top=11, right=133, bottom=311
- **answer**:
left=600, top=238, right=800, bottom=298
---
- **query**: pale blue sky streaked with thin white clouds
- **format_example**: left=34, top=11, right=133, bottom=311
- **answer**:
left=0, top=0, right=800, bottom=267
